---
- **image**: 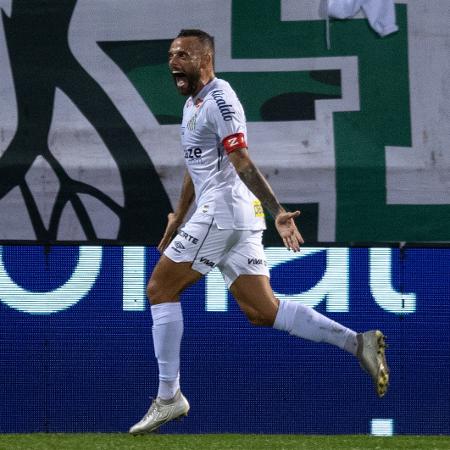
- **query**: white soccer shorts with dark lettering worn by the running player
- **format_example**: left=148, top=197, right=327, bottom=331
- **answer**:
left=164, top=221, right=270, bottom=287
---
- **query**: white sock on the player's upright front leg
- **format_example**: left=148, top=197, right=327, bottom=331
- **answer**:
left=151, top=302, right=184, bottom=400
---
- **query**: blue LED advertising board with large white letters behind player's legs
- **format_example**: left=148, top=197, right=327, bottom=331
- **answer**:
left=0, top=245, right=450, bottom=434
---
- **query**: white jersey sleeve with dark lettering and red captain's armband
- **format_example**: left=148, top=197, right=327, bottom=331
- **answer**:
left=208, top=89, right=247, bottom=153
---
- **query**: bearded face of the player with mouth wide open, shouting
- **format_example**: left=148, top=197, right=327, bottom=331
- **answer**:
left=169, top=36, right=203, bottom=96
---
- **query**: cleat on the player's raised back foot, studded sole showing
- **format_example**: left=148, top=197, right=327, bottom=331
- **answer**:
left=356, top=330, right=389, bottom=397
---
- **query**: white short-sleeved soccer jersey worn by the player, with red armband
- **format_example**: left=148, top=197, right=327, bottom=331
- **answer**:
left=181, top=78, right=266, bottom=230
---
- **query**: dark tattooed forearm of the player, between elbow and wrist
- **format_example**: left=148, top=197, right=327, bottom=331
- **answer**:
left=237, top=161, right=284, bottom=217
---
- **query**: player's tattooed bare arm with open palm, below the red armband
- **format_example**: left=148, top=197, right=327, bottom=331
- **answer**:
left=228, top=148, right=304, bottom=252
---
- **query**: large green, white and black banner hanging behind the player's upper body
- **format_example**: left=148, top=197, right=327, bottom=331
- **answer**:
left=0, top=0, right=450, bottom=245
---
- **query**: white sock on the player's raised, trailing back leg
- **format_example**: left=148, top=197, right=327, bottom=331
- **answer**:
left=273, top=300, right=357, bottom=356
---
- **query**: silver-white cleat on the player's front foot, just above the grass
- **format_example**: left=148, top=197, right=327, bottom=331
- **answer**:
left=129, top=390, right=189, bottom=434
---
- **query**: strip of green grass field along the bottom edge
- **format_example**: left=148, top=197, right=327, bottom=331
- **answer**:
left=0, top=433, right=450, bottom=450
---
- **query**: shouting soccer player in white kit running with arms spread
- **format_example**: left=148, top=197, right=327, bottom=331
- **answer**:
left=130, top=30, right=389, bottom=434
